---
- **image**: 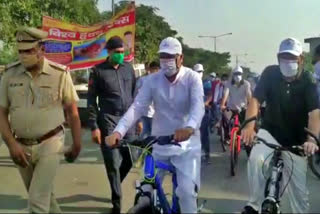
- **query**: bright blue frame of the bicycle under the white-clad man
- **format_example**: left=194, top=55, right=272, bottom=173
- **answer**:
left=144, top=154, right=179, bottom=214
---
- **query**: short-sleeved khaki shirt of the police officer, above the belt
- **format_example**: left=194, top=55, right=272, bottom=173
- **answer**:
left=0, top=60, right=79, bottom=139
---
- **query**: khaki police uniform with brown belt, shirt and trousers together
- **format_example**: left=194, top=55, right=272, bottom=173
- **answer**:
left=0, top=28, right=79, bottom=213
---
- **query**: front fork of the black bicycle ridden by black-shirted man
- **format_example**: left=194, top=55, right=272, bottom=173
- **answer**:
left=261, top=151, right=284, bottom=213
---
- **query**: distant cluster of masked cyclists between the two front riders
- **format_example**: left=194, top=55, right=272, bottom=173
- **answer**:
left=193, top=64, right=259, bottom=164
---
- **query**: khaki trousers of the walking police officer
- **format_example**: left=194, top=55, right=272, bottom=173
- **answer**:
left=18, top=131, right=64, bottom=213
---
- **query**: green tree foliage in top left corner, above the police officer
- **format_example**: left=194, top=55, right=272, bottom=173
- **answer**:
left=0, top=0, right=101, bottom=63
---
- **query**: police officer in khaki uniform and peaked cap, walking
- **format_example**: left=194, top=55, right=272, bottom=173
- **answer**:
left=0, top=27, right=81, bottom=213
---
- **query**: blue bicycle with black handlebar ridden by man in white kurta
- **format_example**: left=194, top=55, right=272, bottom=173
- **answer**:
left=121, top=136, right=203, bottom=214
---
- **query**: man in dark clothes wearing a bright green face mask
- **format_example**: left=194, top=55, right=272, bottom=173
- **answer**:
left=88, top=37, right=136, bottom=213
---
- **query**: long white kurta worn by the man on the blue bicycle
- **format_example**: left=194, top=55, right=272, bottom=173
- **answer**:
left=114, top=67, right=204, bottom=187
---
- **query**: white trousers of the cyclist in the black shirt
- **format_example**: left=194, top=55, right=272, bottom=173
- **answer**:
left=248, top=129, right=309, bottom=213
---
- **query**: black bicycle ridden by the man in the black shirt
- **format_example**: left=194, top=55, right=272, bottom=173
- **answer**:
left=240, top=117, right=320, bottom=214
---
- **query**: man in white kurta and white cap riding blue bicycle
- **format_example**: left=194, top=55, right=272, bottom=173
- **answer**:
left=106, top=37, right=204, bottom=213
